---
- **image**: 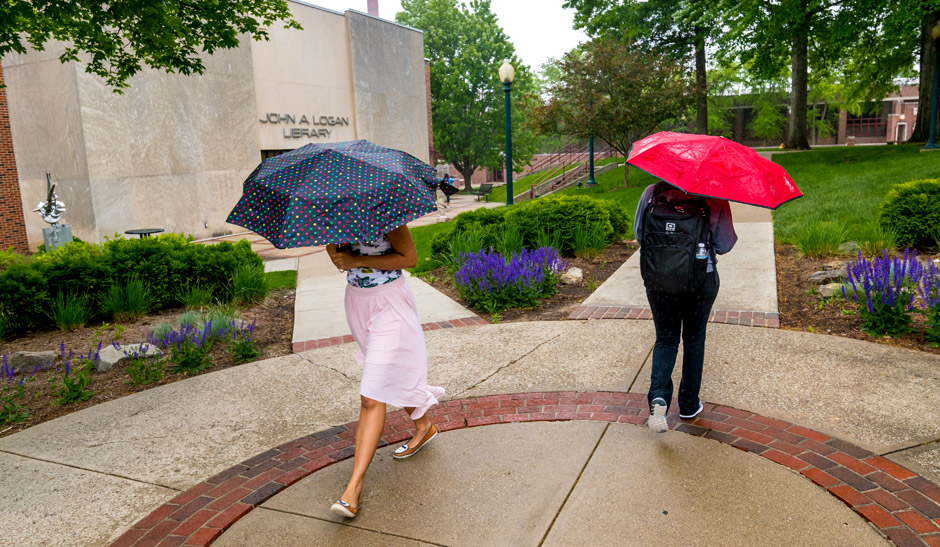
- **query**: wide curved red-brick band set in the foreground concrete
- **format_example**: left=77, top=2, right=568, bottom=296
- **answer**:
left=112, top=391, right=940, bottom=547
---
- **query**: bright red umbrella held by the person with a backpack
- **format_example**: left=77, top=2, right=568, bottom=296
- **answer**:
left=627, top=131, right=803, bottom=209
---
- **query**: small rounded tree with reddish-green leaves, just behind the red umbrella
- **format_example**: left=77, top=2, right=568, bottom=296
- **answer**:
left=533, top=39, right=693, bottom=186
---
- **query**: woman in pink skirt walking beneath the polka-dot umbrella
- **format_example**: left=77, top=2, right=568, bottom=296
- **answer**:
left=326, top=226, right=444, bottom=518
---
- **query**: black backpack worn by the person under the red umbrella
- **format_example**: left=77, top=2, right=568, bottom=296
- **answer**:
left=640, top=187, right=711, bottom=293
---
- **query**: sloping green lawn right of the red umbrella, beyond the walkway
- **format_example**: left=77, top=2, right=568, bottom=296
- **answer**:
left=773, top=144, right=940, bottom=243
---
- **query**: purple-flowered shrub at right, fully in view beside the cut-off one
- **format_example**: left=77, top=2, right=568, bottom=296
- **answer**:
left=842, top=249, right=924, bottom=336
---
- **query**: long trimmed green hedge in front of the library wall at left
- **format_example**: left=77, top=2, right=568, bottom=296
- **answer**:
left=0, top=234, right=263, bottom=332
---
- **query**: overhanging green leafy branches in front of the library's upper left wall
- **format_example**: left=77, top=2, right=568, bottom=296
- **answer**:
left=0, top=0, right=301, bottom=93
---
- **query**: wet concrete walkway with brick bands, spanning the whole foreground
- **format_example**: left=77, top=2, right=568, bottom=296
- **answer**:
left=0, top=195, right=940, bottom=545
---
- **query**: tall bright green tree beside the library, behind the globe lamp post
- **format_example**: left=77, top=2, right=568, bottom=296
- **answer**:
left=396, top=0, right=536, bottom=193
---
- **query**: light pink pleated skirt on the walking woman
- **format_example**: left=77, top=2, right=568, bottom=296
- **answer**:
left=345, top=276, right=444, bottom=420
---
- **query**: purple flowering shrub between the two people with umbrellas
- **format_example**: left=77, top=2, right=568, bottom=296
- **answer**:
left=454, top=247, right=568, bottom=315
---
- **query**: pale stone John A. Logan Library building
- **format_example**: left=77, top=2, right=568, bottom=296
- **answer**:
left=0, top=0, right=430, bottom=251
